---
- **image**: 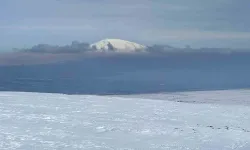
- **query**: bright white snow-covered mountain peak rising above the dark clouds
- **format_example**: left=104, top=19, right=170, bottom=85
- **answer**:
left=90, top=39, right=146, bottom=53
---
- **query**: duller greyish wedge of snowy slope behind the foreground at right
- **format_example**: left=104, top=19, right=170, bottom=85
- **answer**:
left=117, top=90, right=250, bottom=106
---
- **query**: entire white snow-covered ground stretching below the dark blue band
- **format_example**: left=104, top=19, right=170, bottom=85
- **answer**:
left=0, top=90, right=250, bottom=150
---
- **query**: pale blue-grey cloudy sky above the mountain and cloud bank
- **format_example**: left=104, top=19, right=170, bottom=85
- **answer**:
left=0, top=0, right=250, bottom=50
